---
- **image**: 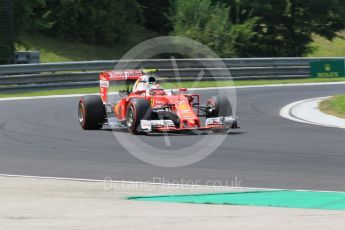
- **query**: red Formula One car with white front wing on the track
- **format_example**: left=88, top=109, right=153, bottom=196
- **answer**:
left=78, top=70, right=237, bottom=134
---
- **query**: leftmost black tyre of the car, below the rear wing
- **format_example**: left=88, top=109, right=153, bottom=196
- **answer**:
left=78, top=95, right=106, bottom=130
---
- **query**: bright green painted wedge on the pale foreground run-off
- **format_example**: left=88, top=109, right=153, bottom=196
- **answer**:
left=128, top=190, right=345, bottom=210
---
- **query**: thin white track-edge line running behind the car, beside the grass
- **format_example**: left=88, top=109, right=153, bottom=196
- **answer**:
left=0, top=82, right=345, bottom=101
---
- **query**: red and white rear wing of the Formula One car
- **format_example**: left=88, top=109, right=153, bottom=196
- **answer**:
left=99, top=69, right=157, bottom=103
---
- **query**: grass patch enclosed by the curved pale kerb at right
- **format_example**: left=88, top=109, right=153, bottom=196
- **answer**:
left=320, top=95, right=345, bottom=118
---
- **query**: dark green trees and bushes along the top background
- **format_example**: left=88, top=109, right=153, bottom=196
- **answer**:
left=14, top=0, right=345, bottom=57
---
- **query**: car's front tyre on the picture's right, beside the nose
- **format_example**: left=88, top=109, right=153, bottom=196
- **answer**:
left=206, top=95, right=232, bottom=117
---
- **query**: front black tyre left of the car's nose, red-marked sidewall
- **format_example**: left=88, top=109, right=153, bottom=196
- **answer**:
left=126, top=98, right=152, bottom=134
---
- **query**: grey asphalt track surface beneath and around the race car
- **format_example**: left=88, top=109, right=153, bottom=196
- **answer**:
left=0, top=85, right=345, bottom=191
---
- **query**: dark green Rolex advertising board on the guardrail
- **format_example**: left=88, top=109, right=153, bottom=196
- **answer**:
left=310, top=60, right=345, bottom=78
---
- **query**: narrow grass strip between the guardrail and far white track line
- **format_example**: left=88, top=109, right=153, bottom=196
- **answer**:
left=0, top=78, right=345, bottom=98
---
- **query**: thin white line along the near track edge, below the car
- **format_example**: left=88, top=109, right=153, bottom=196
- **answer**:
left=0, top=174, right=345, bottom=193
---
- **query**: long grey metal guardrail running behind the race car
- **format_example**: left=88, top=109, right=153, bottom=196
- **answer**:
left=0, top=58, right=344, bottom=91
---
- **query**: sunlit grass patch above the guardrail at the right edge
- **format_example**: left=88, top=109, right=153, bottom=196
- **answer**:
left=308, top=31, right=345, bottom=57
